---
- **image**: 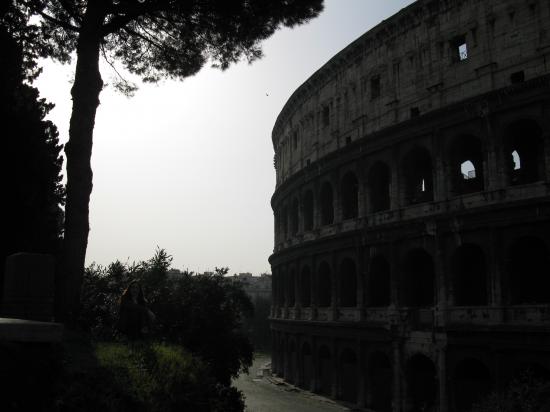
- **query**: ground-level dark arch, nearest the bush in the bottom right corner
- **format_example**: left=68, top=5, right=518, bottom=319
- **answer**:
left=452, top=358, right=492, bottom=412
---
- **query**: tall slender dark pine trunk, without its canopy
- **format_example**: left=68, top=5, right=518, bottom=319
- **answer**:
left=56, top=0, right=105, bottom=322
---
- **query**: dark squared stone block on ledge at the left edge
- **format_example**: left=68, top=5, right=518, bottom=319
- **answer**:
left=1, top=253, right=55, bottom=321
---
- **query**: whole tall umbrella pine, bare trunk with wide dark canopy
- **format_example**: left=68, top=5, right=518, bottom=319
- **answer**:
left=0, top=0, right=323, bottom=319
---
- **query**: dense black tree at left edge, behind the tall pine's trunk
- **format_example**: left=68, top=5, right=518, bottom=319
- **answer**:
left=0, top=27, right=65, bottom=276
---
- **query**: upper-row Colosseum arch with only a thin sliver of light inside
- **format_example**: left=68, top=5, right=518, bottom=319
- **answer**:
left=402, top=146, right=433, bottom=205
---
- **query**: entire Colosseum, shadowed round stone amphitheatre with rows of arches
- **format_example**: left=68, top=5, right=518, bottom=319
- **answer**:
left=270, top=0, right=550, bottom=412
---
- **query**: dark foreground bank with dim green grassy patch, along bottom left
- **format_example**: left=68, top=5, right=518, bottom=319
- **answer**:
left=0, top=341, right=244, bottom=412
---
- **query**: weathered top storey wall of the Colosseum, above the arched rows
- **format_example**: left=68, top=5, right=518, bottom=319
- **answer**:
left=272, top=0, right=550, bottom=187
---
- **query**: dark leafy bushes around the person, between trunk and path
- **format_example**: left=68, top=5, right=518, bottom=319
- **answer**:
left=80, top=249, right=253, bottom=386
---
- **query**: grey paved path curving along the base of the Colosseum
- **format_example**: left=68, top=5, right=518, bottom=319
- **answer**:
left=234, top=354, right=352, bottom=412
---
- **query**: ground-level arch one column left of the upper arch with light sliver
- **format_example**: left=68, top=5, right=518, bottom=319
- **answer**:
left=367, top=352, right=393, bottom=412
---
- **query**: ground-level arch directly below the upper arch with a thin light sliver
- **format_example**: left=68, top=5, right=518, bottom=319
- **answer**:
left=406, top=354, right=437, bottom=411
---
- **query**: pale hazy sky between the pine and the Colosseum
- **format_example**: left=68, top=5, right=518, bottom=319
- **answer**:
left=36, top=0, right=413, bottom=274
